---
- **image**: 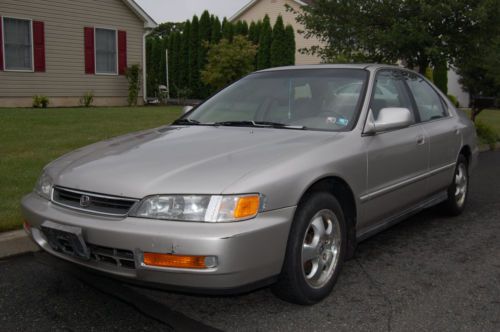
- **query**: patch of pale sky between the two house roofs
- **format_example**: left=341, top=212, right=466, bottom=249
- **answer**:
left=135, top=0, right=250, bottom=23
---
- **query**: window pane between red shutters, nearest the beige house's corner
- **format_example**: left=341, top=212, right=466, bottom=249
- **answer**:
left=95, top=28, right=118, bottom=74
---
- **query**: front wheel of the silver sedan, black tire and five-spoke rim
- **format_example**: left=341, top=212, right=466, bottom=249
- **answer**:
left=272, top=192, right=347, bottom=305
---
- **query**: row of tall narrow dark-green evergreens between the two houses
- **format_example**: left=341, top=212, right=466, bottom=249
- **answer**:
left=146, top=11, right=295, bottom=99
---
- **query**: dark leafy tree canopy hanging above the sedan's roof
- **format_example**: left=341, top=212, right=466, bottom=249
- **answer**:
left=297, top=0, right=497, bottom=73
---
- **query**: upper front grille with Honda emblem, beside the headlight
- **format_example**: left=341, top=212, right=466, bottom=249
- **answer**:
left=52, top=187, right=138, bottom=216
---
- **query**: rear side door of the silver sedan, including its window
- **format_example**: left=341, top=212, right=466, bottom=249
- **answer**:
left=406, top=73, right=461, bottom=193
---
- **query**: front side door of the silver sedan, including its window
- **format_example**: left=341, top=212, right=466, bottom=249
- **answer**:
left=359, top=70, right=429, bottom=233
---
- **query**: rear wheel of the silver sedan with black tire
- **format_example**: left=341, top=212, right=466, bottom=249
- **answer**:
left=442, top=155, right=469, bottom=216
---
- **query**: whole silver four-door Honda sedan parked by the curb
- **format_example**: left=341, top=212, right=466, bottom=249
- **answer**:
left=22, top=65, right=478, bottom=304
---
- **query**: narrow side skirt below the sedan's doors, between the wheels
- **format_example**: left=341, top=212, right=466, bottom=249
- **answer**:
left=357, top=191, right=448, bottom=242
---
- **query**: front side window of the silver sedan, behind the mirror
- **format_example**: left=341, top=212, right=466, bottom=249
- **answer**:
left=370, top=70, right=415, bottom=121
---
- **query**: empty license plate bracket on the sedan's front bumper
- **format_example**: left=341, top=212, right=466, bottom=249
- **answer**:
left=41, top=221, right=90, bottom=260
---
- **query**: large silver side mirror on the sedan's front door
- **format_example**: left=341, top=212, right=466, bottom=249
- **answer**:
left=365, top=107, right=413, bottom=134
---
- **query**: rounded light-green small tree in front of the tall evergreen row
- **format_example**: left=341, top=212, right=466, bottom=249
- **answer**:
left=201, top=35, right=257, bottom=90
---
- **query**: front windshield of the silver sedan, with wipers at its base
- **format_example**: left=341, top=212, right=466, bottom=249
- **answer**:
left=180, top=69, right=368, bottom=131
